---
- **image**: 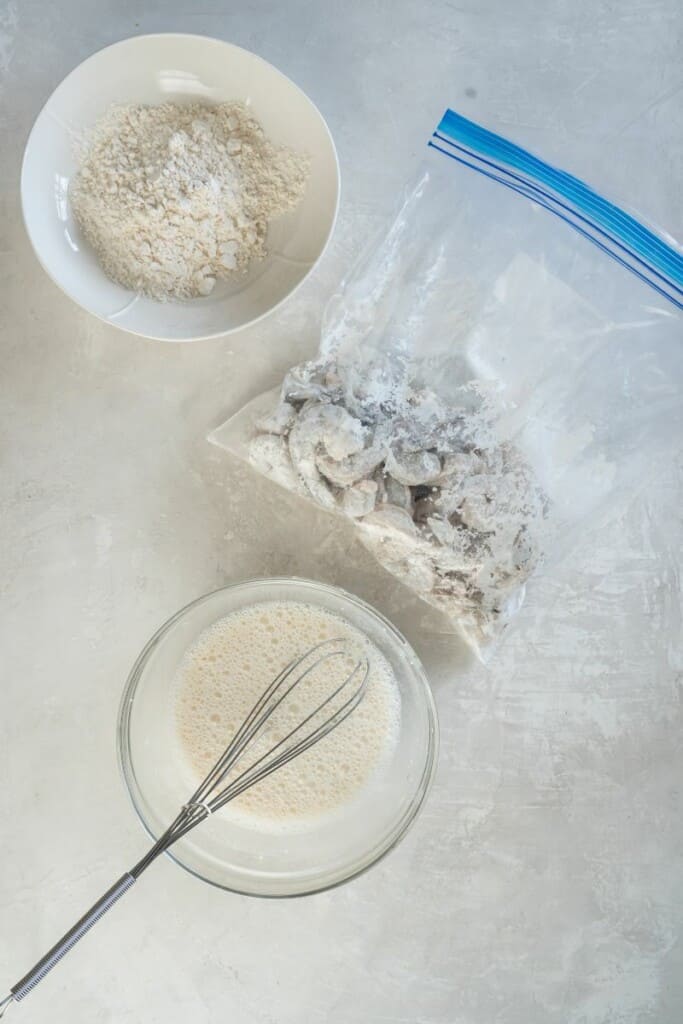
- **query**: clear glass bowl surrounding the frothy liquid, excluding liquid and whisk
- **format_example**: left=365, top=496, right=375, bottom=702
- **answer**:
left=118, top=579, right=438, bottom=896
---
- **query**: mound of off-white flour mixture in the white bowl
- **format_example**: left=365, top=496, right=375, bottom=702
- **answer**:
left=70, top=102, right=308, bottom=300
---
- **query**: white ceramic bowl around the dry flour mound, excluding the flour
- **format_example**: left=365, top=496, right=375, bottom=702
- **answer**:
left=22, top=34, right=339, bottom=341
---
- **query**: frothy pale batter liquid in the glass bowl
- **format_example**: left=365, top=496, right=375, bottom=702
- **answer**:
left=175, top=601, right=400, bottom=823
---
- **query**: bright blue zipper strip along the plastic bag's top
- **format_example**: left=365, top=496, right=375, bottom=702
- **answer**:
left=429, top=111, right=683, bottom=309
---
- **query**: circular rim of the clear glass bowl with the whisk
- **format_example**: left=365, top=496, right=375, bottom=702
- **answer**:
left=117, top=575, right=439, bottom=899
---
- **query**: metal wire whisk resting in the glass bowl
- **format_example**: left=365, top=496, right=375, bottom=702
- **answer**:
left=0, top=638, right=370, bottom=1017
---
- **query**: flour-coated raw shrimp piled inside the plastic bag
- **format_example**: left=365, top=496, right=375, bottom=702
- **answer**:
left=249, top=359, right=547, bottom=650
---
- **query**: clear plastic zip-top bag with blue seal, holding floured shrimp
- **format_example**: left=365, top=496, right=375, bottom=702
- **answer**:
left=210, top=111, right=683, bottom=655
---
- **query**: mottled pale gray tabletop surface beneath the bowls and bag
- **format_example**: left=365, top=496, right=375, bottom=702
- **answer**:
left=0, top=0, right=683, bottom=1024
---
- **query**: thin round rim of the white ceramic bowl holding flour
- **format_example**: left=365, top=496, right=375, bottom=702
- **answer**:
left=19, top=32, right=341, bottom=345
